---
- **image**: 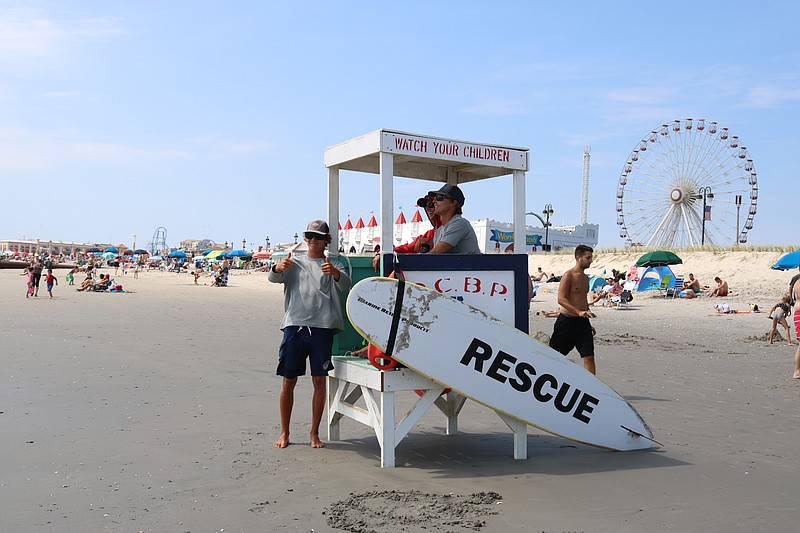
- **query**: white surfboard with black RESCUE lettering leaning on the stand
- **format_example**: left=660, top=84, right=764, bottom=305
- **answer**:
left=347, top=278, right=655, bottom=450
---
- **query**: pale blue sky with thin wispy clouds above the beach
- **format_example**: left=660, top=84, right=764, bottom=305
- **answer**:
left=0, top=0, right=800, bottom=248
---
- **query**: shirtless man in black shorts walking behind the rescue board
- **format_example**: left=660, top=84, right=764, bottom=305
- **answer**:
left=550, top=244, right=597, bottom=374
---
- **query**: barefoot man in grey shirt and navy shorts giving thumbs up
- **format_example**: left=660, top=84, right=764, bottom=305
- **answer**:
left=267, top=220, right=350, bottom=448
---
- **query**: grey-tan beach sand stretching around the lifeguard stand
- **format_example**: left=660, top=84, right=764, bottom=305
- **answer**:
left=0, top=252, right=800, bottom=532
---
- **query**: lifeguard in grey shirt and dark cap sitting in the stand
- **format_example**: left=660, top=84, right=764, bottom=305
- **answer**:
left=428, top=183, right=481, bottom=254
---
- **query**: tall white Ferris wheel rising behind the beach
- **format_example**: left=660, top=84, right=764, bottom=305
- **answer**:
left=617, top=118, right=758, bottom=248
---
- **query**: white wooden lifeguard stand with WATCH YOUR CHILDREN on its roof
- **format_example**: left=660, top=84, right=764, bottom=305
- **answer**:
left=318, top=129, right=529, bottom=467
